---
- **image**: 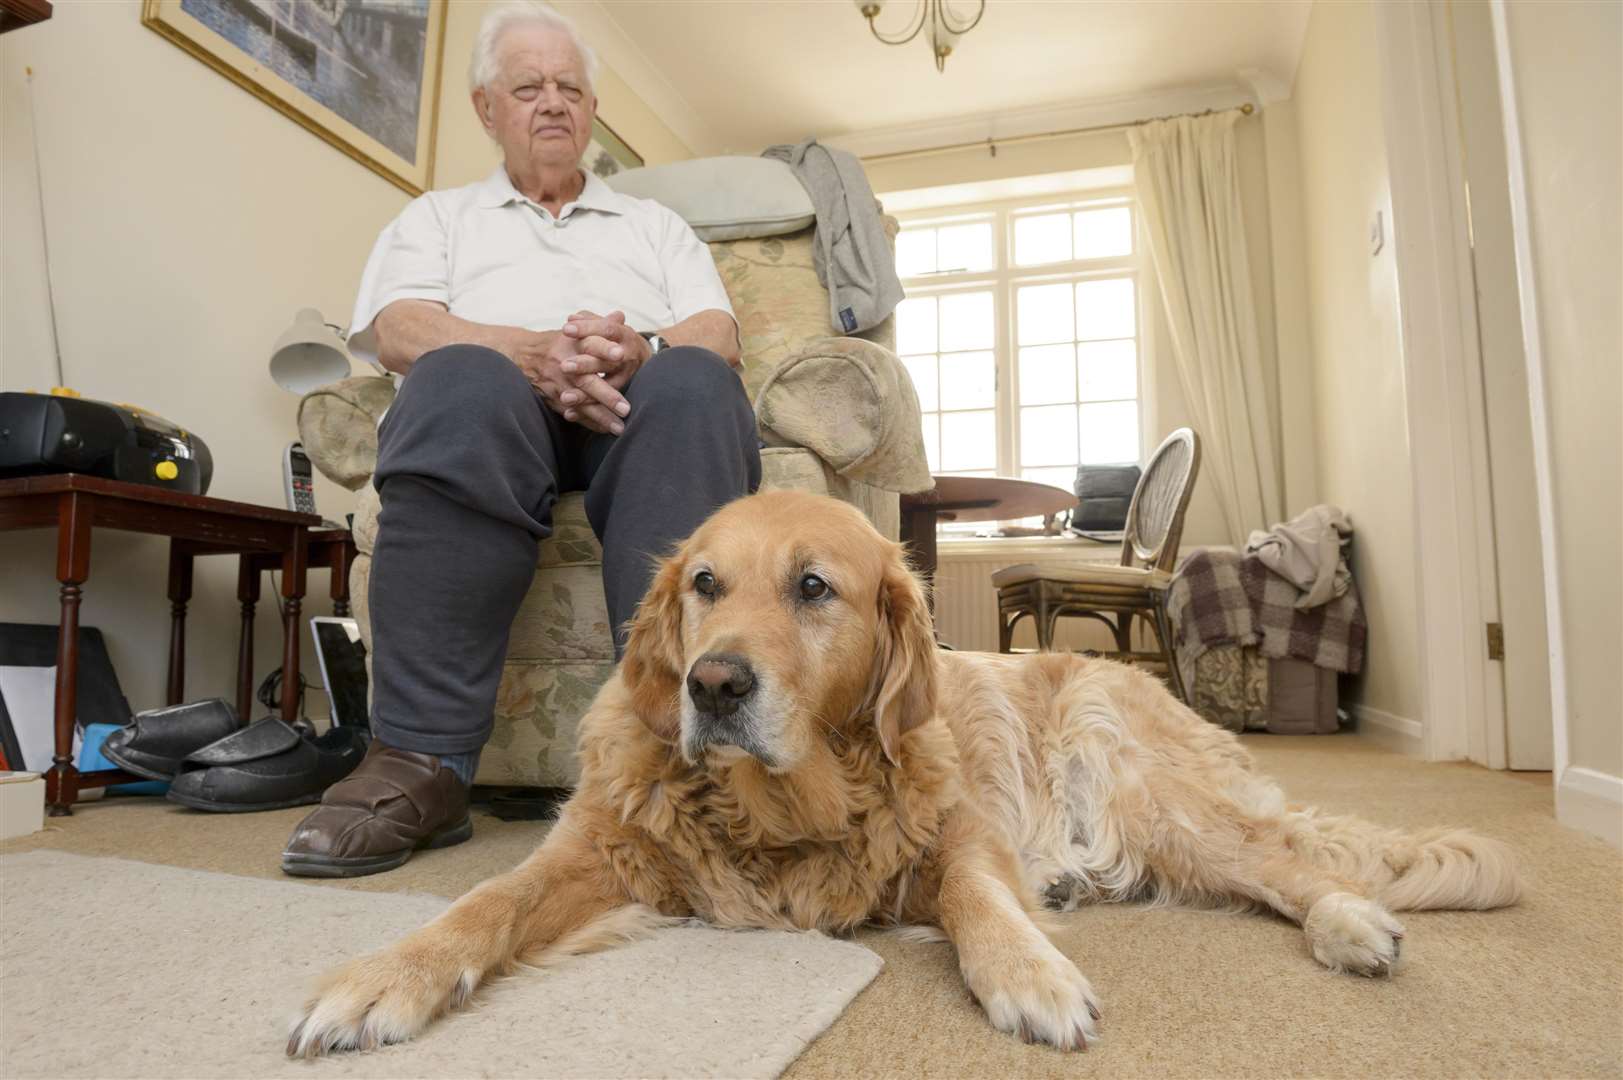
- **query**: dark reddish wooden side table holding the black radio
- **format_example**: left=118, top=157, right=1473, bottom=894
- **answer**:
left=0, top=473, right=319, bottom=817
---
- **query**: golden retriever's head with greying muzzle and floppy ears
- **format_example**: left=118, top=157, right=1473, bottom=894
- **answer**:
left=623, top=492, right=935, bottom=773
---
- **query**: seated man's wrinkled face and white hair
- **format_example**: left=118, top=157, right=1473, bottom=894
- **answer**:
left=474, top=24, right=597, bottom=171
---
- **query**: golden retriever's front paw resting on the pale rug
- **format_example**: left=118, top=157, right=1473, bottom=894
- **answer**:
left=287, top=940, right=480, bottom=1057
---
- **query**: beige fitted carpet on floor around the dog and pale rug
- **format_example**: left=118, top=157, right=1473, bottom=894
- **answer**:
left=0, top=736, right=1623, bottom=1080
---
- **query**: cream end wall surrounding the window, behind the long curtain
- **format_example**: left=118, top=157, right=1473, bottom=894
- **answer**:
left=863, top=115, right=1313, bottom=546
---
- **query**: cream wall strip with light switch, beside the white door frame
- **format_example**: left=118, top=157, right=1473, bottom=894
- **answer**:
left=1292, top=3, right=1422, bottom=736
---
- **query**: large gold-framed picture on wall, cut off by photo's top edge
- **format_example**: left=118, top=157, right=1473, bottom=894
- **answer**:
left=141, top=0, right=446, bottom=195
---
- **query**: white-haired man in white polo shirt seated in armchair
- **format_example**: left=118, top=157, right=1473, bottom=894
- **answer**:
left=282, top=3, right=761, bottom=877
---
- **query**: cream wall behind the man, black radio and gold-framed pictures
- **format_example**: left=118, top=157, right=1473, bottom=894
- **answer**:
left=0, top=0, right=687, bottom=727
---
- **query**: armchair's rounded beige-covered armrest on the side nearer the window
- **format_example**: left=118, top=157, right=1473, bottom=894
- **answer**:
left=755, top=338, right=935, bottom=494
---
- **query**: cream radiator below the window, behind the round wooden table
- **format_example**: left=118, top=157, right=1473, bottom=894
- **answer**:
left=935, top=538, right=1121, bottom=653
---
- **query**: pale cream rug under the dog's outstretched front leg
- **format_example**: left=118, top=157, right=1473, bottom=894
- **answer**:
left=0, top=851, right=883, bottom=1080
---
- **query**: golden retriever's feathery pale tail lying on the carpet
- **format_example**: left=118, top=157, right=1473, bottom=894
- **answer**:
left=1292, top=815, right=1521, bottom=911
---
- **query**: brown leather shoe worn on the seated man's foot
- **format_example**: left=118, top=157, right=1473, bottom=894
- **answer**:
left=282, top=741, right=474, bottom=877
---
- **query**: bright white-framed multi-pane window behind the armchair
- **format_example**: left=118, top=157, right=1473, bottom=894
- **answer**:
left=896, top=193, right=1143, bottom=489
